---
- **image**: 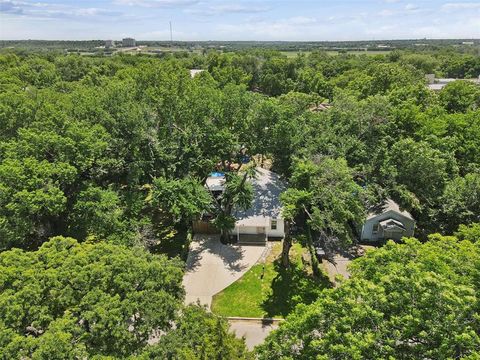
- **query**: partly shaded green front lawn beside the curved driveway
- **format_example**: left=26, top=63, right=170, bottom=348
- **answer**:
left=212, top=242, right=330, bottom=318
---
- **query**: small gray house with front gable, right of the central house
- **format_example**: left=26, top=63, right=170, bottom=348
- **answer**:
left=361, top=199, right=415, bottom=242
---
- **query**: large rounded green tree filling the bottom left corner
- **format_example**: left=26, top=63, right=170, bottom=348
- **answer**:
left=0, top=237, right=184, bottom=359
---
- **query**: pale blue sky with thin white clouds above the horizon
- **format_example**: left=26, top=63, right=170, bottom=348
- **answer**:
left=0, top=0, right=480, bottom=41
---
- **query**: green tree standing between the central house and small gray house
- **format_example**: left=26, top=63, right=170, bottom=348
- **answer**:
left=282, top=158, right=364, bottom=270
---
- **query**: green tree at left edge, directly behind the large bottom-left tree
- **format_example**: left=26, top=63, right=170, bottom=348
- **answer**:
left=0, top=157, right=77, bottom=249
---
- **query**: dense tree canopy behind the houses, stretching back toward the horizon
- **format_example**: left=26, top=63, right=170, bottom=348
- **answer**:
left=0, top=49, right=480, bottom=249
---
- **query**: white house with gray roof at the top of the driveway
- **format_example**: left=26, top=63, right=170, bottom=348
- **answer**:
left=202, top=167, right=285, bottom=244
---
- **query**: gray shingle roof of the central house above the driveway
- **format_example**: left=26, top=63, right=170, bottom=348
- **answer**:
left=234, top=167, right=285, bottom=226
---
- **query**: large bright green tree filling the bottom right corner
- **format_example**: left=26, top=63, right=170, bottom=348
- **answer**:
left=256, top=235, right=480, bottom=359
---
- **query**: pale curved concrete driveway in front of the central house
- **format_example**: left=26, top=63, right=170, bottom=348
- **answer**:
left=183, top=235, right=267, bottom=309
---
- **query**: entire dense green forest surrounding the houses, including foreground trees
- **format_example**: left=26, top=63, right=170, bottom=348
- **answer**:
left=0, top=48, right=480, bottom=359
